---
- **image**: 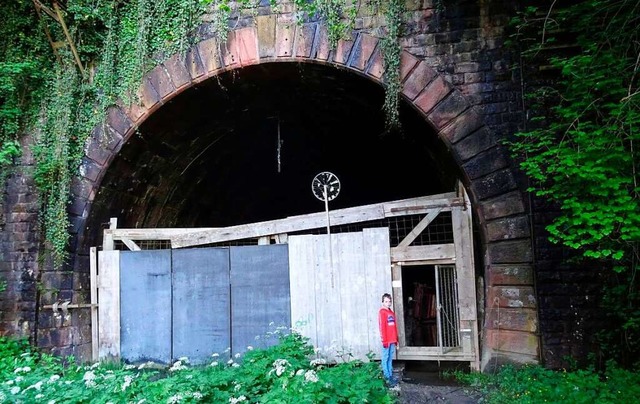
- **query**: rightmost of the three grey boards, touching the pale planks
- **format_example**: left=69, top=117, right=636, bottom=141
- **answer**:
left=230, top=244, right=291, bottom=354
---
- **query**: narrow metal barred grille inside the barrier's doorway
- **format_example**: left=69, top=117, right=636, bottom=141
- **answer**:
left=436, top=265, right=460, bottom=348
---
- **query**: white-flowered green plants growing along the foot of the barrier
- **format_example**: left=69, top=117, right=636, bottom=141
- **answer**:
left=0, top=334, right=394, bottom=404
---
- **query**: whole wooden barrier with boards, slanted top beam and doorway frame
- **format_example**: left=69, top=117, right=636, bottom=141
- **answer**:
left=92, top=187, right=479, bottom=369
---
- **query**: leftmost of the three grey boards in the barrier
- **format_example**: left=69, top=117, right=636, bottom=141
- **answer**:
left=120, top=250, right=171, bottom=363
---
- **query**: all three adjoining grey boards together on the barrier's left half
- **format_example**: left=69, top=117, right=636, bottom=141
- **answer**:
left=120, top=245, right=291, bottom=363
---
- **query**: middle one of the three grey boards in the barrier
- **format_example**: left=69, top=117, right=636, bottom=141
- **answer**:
left=172, top=248, right=231, bottom=364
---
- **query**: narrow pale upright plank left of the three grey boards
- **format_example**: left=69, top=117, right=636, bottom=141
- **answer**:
left=97, top=251, right=120, bottom=361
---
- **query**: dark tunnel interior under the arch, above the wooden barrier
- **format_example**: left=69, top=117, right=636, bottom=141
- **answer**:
left=87, top=63, right=458, bottom=245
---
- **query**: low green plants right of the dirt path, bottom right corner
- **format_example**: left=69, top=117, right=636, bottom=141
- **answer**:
left=454, top=365, right=640, bottom=404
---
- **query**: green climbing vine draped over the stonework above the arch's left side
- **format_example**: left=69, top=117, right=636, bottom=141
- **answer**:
left=0, top=0, right=404, bottom=266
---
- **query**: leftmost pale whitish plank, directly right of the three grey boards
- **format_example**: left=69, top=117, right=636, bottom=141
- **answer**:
left=288, top=235, right=318, bottom=347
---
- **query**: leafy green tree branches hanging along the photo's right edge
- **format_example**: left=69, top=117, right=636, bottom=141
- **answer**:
left=510, top=0, right=640, bottom=363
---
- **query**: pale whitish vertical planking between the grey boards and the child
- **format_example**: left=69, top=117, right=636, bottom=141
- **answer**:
left=289, top=228, right=391, bottom=360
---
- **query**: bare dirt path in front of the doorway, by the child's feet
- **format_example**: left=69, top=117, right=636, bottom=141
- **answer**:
left=393, top=362, right=482, bottom=404
